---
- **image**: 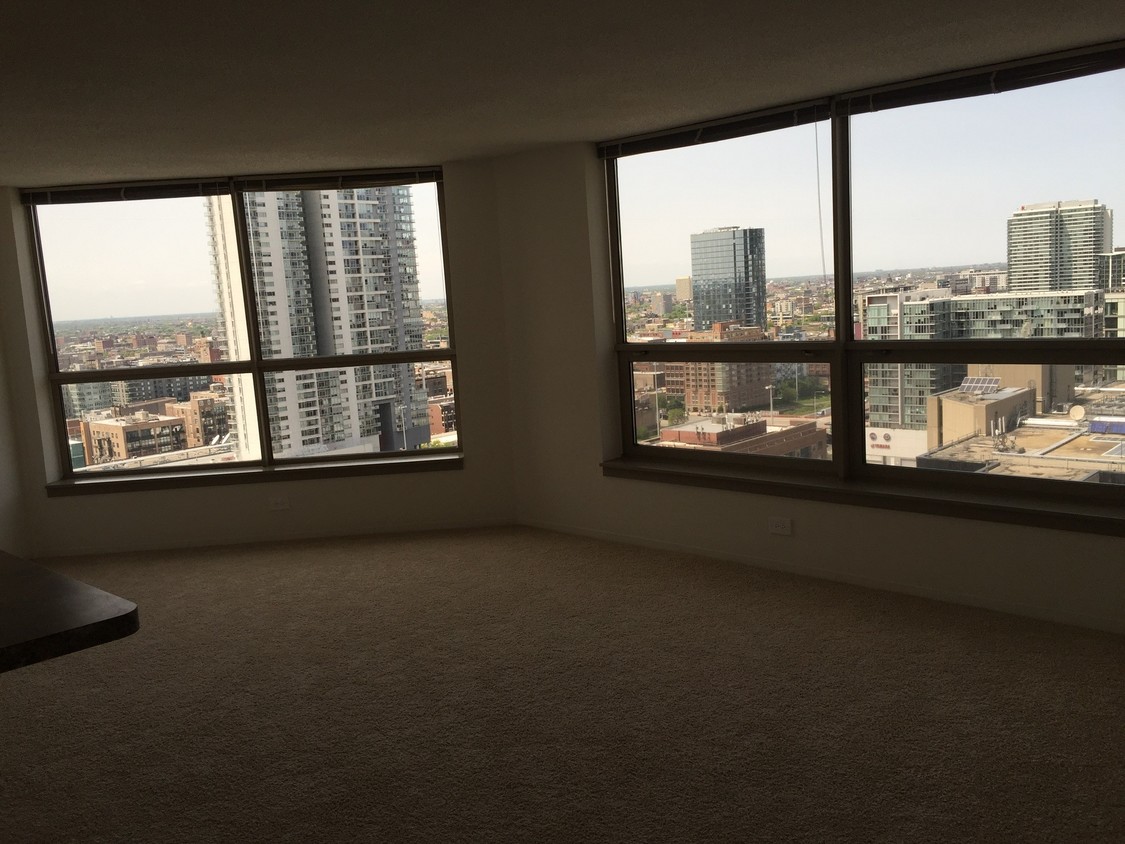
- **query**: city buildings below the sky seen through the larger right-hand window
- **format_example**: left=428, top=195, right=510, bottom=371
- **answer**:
left=624, top=167, right=1125, bottom=484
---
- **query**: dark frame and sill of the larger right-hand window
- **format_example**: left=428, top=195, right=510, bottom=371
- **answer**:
left=599, top=42, right=1125, bottom=536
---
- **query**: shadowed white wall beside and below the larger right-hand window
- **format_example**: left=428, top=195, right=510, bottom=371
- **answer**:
left=496, top=145, right=1125, bottom=632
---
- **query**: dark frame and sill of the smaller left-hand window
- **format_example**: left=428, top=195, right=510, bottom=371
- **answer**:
left=19, top=167, right=464, bottom=496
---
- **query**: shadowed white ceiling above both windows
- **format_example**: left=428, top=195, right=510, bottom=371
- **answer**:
left=0, top=0, right=1125, bottom=187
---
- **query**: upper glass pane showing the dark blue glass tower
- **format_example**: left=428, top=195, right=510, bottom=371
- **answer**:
left=618, top=123, right=835, bottom=342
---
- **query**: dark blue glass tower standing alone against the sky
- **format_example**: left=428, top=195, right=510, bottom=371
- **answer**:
left=692, top=226, right=766, bottom=331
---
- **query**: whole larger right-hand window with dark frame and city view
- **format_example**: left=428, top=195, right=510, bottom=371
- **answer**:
left=600, top=47, right=1125, bottom=532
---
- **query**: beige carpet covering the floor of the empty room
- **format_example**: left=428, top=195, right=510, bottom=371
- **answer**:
left=0, top=528, right=1125, bottom=843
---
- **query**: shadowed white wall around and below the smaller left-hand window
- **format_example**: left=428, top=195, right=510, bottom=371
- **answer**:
left=0, top=163, right=513, bottom=556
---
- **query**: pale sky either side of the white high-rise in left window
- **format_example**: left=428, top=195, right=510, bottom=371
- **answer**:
left=38, top=185, right=446, bottom=320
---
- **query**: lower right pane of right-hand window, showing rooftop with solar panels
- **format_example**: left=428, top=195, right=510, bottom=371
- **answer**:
left=864, top=362, right=1125, bottom=484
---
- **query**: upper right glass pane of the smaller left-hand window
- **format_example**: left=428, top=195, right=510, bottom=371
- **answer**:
left=235, top=185, right=449, bottom=358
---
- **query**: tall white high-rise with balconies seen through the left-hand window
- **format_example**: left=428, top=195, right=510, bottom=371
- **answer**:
left=208, top=186, right=430, bottom=457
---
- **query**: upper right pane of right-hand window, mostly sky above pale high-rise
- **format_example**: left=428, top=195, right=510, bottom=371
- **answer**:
left=852, top=71, right=1125, bottom=340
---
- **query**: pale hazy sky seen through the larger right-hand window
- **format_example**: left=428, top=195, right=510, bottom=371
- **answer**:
left=618, top=71, right=1125, bottom=287
